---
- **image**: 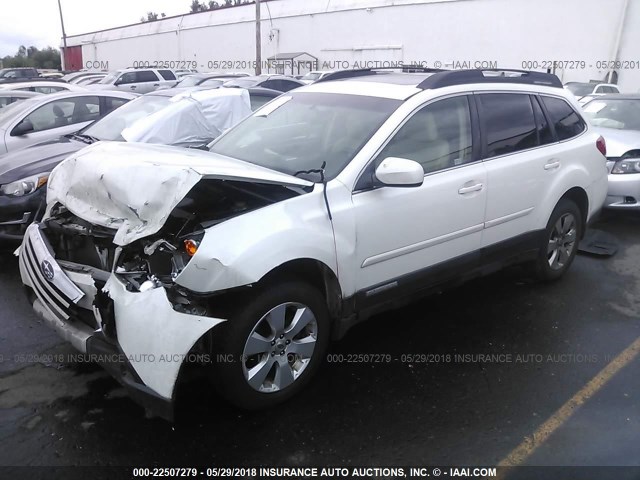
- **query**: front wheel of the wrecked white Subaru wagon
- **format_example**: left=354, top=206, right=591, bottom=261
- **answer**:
left=211, top=281, right=331, bottom=410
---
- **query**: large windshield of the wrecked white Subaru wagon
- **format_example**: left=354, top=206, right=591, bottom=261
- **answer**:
left=211, top=93, right=400, bottom=181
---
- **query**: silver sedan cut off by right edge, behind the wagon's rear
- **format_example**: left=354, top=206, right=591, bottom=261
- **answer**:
left=583, top=95, right=640, bottom=210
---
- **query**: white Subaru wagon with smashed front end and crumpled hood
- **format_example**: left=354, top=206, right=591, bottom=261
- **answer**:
left=19, top=70, right=607, bottom=418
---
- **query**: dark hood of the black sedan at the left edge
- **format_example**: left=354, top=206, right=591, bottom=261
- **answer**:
left=0, top=137, right=87, bottom=185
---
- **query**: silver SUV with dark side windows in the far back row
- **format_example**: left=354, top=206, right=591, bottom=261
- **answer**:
left=86, top=68, right=178, bottom=94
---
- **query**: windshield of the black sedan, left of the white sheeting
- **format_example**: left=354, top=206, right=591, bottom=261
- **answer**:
left=82, top=95, right=171, bottom=142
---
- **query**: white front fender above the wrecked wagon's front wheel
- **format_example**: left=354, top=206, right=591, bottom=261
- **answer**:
left=175, top=185, right=338, bottom=293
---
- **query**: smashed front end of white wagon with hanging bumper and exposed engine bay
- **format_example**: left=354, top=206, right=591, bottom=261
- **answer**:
left=20, top=170, right=302, bottom=418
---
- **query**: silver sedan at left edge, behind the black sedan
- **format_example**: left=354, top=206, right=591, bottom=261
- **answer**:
left=0, top=90, right=137, bottom=155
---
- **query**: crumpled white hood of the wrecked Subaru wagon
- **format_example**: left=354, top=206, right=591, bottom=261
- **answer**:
left=47, top=142, right=313, bottom=245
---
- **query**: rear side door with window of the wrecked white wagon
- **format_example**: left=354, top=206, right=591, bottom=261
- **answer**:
left=475, top=92, right=562, bottom=247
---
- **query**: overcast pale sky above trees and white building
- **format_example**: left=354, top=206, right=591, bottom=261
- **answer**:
left=0, top=0, right=191, bottom=57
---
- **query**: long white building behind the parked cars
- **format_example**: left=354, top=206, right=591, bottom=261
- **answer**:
left=66, top=0, right=640, bottom=92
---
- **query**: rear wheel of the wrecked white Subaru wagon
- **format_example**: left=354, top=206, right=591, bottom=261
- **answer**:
left=534, top=198, right=583, bottom=282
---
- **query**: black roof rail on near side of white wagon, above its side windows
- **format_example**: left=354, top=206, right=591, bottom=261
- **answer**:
left=418, top=68, right=563, bottom=90
